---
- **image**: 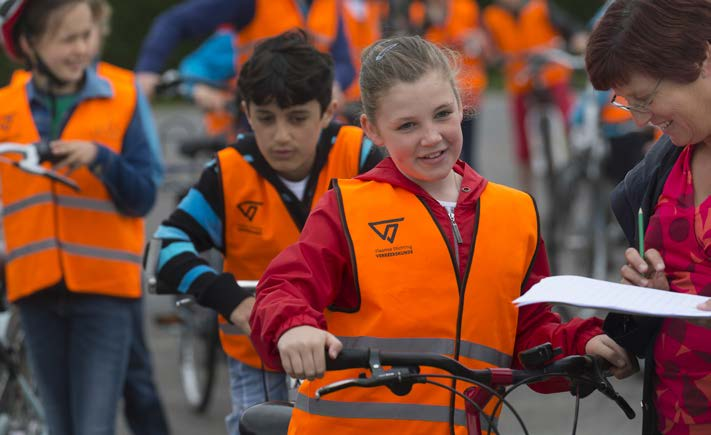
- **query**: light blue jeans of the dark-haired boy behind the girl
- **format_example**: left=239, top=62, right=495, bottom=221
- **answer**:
left=225, top=356, right=288, bottom=435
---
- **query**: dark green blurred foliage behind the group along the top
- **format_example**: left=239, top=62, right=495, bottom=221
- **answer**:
left=0, top=0, right=604, bottom=84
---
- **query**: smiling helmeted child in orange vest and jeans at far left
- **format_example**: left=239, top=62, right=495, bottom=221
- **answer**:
left=0, top=0, right=162, bottom=435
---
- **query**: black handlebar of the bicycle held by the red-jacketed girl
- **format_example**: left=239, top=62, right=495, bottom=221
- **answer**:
left=316, top=349, right=635, bottom=419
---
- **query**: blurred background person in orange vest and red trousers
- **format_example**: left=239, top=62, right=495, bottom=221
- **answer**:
left=482, top=0, right=586, bottom=174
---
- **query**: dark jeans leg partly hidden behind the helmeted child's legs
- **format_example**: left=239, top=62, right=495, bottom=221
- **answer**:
left=123, top=300, right=170, bottom=435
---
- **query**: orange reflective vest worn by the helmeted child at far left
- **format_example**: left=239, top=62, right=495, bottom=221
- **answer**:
left=0, top=66, right=144, bottom=301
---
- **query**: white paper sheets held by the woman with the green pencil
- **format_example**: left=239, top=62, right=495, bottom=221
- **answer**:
left=514, top=275, right=711, bottom=317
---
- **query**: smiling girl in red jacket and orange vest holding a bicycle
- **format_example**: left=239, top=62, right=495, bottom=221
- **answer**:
left=250, top=37, right=636, bottom=434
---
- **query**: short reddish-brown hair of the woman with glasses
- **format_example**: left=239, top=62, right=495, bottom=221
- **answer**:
left=585, top=0, right=711, bottom=90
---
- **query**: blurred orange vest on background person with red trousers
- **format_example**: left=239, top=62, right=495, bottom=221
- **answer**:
left=484, top=0, right=571, bottom=94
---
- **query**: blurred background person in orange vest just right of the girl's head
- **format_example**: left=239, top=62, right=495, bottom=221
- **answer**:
left=410, top=0, right=487, bottom=167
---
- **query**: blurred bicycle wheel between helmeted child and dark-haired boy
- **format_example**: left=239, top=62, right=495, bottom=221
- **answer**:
left=178, top=304, right=220, bottom=414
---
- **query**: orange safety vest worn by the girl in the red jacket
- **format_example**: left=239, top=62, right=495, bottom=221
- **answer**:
left=289, top=180, right=538, bottom=435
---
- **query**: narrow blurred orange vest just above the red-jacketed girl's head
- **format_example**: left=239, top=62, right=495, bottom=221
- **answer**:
left=342, top=0, right=383, bottom=103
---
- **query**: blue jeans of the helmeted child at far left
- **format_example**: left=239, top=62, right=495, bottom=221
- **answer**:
left=17, top=291, right=138, bottom=435
